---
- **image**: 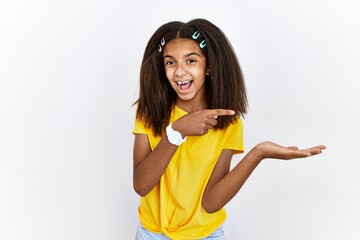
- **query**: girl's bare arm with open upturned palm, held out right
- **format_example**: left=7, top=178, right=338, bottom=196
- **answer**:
left=202, top=142, right=325, bottom=213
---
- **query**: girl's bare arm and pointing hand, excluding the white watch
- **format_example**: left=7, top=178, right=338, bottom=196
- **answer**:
left=133, top=109, right=234, bottom=196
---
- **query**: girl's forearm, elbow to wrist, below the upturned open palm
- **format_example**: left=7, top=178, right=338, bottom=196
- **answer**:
left=202, top=148, right=262, bottom=213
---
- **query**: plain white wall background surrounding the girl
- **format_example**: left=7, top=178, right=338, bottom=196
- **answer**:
left=0, top=0, right=360, bottom=240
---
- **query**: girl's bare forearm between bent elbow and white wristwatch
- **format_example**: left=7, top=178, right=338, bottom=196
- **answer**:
left=133, top=136, right=178, bottom=196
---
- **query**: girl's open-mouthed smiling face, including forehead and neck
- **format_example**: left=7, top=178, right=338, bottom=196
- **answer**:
left=163, top=38, right=207, bottom=110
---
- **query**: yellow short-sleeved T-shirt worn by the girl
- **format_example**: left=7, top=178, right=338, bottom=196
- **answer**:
left=133, top=106, right=243, bottom=240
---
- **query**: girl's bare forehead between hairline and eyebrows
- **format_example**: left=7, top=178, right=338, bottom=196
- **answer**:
left=164, top=38, right=203, bottom=56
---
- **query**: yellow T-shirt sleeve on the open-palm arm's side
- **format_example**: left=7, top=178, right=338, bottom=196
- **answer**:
left=224, top=118, right=244, bottom=154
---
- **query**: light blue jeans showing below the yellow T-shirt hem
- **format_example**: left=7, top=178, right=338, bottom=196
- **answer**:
left=135, top=224, right=225, bottom=240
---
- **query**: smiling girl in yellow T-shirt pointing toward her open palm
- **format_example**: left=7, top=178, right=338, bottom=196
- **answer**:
left=133, top=19, right=325, bottom=240
